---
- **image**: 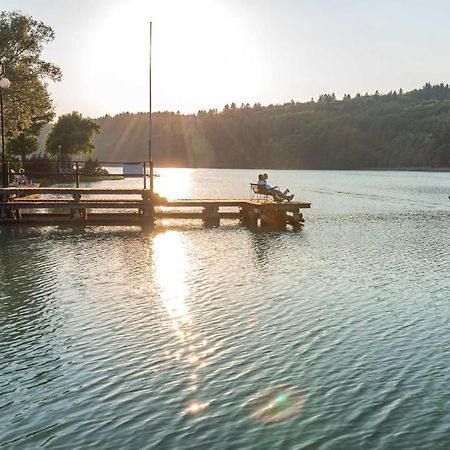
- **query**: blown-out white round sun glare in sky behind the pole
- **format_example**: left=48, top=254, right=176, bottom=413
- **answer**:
left=86, top=0, right=263, bottom=113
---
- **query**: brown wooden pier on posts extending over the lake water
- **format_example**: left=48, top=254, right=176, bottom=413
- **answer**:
left=0, top=187, right=310, bottom=229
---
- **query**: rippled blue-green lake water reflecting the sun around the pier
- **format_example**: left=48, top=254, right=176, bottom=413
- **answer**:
left=0, top=169, right=450, bottom=450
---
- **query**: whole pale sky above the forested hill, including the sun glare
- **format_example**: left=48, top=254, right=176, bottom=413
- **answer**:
left=1, top=0, right=450, bottom=117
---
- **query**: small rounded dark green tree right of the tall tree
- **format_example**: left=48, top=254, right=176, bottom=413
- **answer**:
left=46, top=111, right=100, bottom=159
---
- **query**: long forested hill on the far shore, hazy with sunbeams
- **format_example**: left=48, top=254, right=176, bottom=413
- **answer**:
left=94, top=84, right=450, bottom=169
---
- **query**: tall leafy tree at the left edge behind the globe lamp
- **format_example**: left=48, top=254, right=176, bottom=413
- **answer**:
left=0, top=12, right=61, bottom=162
